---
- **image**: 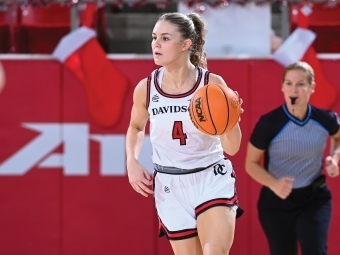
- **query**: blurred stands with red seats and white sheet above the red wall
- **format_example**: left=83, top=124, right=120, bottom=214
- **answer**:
left=0, top=0, right=340, bottom=55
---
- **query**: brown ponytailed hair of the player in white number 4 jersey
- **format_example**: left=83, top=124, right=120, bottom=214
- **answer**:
left=158, top=12, right=207, bottom=68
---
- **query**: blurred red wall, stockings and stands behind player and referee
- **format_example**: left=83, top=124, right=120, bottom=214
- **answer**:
left=0, top=0, right=340, bottom=255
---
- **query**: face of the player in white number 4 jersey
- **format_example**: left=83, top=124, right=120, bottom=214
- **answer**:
left=151, top=20, right=186, bottom=66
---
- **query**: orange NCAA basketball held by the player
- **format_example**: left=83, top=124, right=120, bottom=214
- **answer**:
left=189, top=84, right=241, bottom=135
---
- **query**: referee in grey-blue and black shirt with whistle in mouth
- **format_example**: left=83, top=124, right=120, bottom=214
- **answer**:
left=245, top=62, right=340, bottom=255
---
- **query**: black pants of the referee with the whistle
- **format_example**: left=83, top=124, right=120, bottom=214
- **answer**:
left=257, top=182, right=331, bottom=255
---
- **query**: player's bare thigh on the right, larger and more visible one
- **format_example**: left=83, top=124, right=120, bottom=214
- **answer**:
left=197, top=206, right=236, bottom=254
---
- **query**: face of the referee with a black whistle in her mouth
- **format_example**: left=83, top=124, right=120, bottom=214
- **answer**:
left=282, top=69, right=314, bottom=105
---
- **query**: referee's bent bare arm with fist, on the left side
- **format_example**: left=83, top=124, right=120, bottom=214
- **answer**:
left=245, top=142, right=294, bottom=199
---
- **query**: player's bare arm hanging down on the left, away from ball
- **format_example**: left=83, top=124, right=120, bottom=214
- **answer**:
left=126, top=79, right=153, bottom=197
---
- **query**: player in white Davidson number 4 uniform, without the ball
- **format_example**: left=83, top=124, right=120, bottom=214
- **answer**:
left=126, top=13, right=242, bottom=255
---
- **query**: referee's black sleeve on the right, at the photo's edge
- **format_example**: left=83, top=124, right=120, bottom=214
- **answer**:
left=311, top=106, right=340, bottom=136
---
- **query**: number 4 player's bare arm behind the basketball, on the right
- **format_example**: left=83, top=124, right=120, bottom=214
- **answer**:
left=209, top=74, right=243, bottom=156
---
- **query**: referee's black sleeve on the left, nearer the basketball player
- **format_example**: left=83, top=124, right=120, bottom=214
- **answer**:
left=249, top=106, right=289, bottom=150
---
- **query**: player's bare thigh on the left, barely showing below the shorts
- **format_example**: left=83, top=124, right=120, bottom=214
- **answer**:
left=170, top=236, right=203, bottom=255
